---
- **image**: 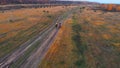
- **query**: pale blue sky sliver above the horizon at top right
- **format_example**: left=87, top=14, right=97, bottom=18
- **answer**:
left=66, top=0, right=120, bottom=4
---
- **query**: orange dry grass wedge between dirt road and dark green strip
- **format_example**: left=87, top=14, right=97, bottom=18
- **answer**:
left=40, top=19, right=77, bottom=68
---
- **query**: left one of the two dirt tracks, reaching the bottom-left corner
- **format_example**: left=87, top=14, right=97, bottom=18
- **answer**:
left=0, top=12, right=61, bottom=68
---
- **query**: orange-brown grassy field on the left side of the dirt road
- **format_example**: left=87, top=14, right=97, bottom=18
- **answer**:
left=0, top=6, right=76, bottom=57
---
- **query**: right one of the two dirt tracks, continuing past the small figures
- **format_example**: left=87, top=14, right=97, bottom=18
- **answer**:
left=20, top=9, right=74, bottom=68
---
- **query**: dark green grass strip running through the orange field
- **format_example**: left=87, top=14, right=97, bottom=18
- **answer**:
left=72, top=14, right=87, bottom=68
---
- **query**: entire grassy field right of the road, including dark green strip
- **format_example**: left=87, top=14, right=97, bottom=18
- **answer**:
left=39, top=6, right=120, bottom=68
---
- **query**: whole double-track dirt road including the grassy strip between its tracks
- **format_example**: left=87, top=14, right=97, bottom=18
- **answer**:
left=0, top=6, right=77, bottom=68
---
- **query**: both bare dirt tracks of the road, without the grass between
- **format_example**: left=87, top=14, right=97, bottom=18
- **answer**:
left=0, top=7, right=77, bottom=68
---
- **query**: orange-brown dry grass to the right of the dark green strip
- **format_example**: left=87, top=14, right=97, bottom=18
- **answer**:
left=79, top=7, right=120, bottom=68
